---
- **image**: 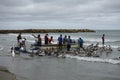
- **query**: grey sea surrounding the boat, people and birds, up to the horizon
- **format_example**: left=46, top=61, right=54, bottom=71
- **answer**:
left=0, top=30, right=120, bottom=80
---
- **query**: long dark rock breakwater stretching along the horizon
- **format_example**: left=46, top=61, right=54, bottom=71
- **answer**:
left=0, top=29, right=96, bottom=34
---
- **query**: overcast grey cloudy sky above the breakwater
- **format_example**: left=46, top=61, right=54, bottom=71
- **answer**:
left=0, top=0, right=120, bottom=30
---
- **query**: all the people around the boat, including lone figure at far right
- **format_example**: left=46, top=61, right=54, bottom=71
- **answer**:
left=17, top=33, right=105, bottom=51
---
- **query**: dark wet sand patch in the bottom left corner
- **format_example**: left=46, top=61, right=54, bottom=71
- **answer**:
left=0, top=66, right=16, bottom=80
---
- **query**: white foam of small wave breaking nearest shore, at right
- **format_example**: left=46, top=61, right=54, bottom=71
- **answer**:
left=66, top=55, right=120, bottom=64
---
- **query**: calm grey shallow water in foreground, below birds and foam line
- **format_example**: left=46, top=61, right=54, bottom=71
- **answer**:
left=0, top=56, right=120, bottom=80
